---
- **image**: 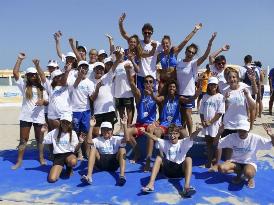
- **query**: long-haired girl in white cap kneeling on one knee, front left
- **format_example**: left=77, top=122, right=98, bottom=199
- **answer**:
left=42, top=113, right=84, bottom=183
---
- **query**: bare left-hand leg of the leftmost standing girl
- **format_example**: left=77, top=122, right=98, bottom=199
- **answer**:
left=11, top=125, right=31, bottom=170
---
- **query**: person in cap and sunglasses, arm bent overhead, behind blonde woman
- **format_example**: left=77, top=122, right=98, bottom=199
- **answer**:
left=209, top=44, right=230, bottom=93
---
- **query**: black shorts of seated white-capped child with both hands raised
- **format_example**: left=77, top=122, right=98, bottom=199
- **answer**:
left=95, top=154, right=120, bottom=171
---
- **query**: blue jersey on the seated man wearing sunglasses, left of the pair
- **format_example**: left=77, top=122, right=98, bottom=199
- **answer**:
left=136, top=93, right=157, bottom=124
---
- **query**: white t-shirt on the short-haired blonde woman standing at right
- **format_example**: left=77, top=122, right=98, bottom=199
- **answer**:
left=223, top=83, right=251, bottom=130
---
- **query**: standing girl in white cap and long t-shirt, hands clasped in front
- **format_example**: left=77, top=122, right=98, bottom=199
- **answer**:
left=199, top=77, right=225, bottom=168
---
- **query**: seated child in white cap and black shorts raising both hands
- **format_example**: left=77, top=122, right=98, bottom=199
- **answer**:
left=81, top=116, right=128, bottom=186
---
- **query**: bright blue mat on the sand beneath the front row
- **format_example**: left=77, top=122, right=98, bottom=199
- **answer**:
left=0, top=150, right=274, bottom=204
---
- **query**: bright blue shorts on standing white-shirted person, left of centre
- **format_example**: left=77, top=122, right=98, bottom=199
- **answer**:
left=72, top=110, right=91, bottom=134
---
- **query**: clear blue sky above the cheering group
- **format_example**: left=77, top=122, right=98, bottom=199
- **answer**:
left=0, top=0, right=274, bottom=70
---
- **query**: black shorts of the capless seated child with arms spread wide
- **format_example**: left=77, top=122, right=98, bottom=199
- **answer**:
left=161, top=158, right=184, bottom=178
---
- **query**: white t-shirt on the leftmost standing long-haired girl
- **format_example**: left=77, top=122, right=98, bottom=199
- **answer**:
left=15, top=77, right=48, bottom=124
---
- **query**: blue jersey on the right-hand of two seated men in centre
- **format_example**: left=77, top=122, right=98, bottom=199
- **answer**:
left=160, top=96, right=182, bottom=127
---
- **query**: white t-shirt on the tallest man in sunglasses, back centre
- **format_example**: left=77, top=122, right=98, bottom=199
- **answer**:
left=140, top=40, right=163, bottom=79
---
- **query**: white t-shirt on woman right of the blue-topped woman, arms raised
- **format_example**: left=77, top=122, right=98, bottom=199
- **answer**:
left=176, top=59, right=198, bottom=96
